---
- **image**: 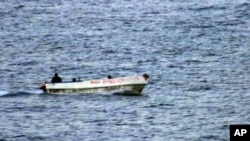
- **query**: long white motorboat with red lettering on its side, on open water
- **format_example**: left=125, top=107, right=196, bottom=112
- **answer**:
left=39, top=74, right=149, bottom=95
